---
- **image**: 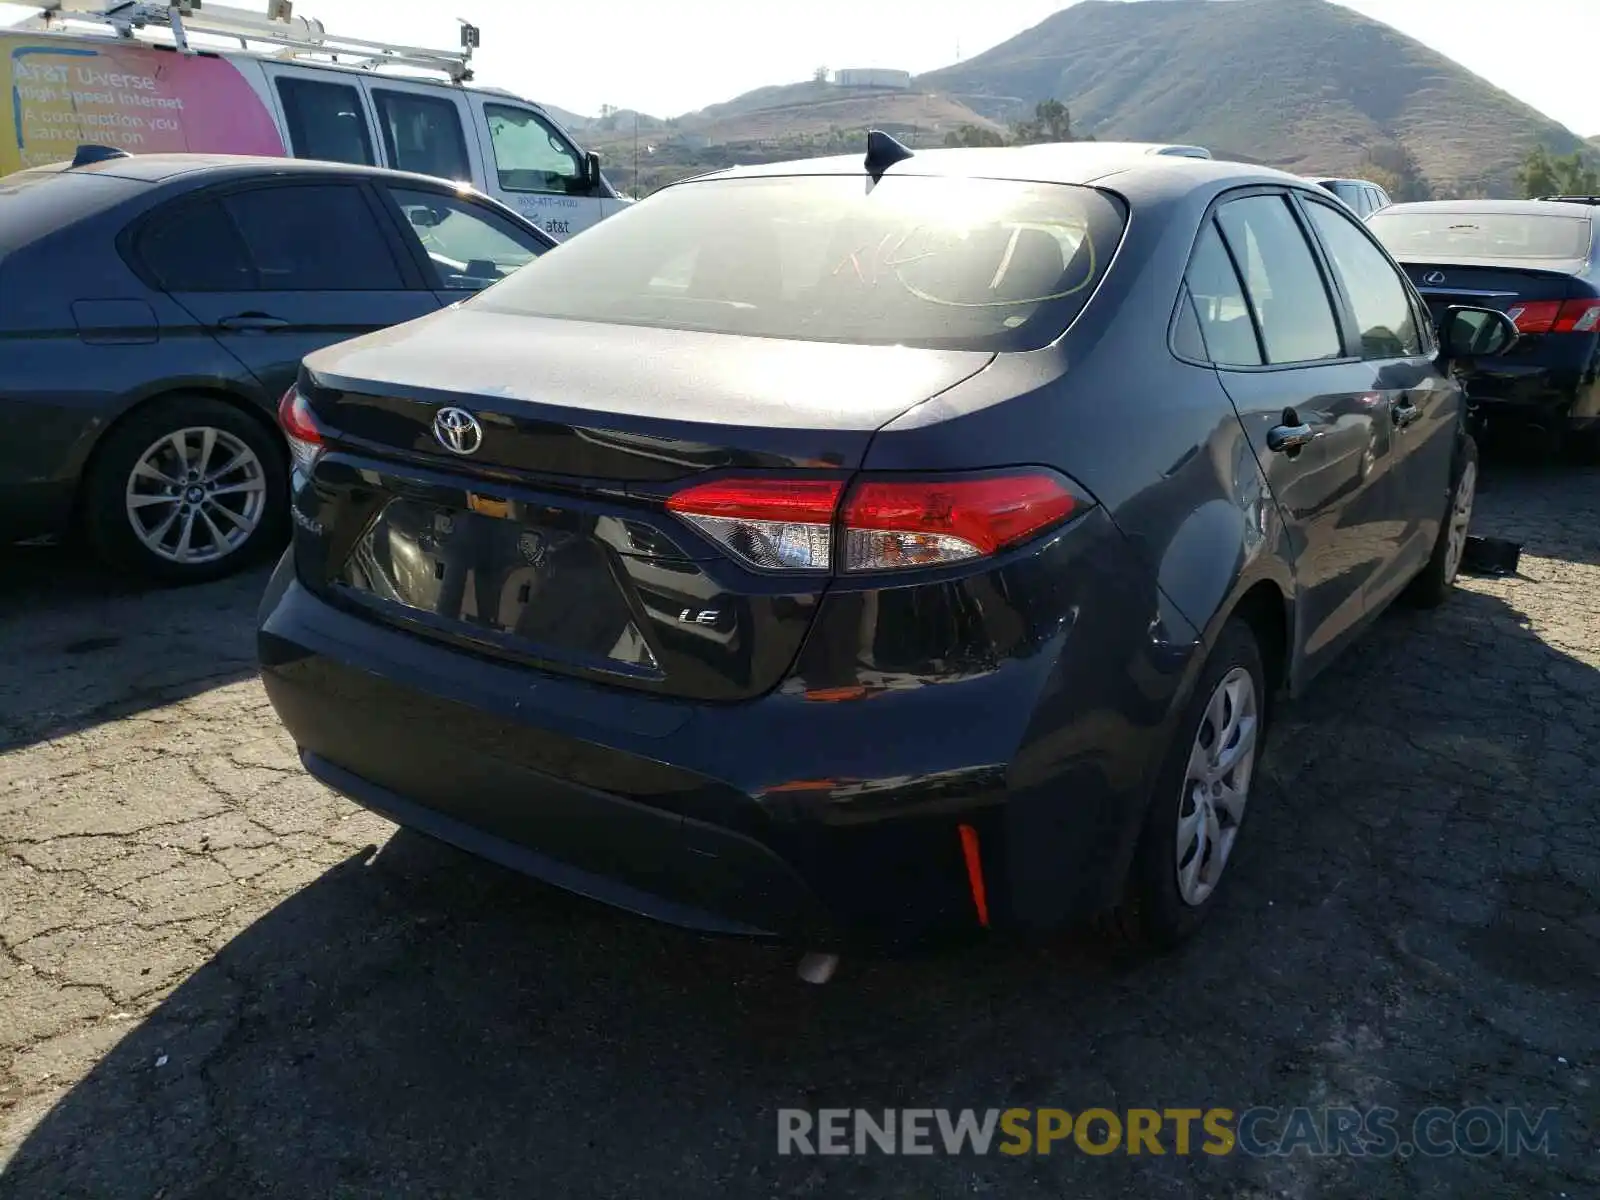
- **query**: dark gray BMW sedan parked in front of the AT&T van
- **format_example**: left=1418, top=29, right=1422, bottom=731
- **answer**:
left=0, top=146, right=555, bottom=582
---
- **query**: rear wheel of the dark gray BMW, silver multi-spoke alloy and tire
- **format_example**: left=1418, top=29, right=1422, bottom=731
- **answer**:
left=82, top=395, right=288, bottom=584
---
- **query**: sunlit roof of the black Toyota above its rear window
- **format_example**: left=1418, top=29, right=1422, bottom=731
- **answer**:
left=685, top=142, right=1310, bottom=192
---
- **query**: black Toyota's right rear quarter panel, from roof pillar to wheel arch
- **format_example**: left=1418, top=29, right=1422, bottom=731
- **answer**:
left=866, top=178, right=1293, bottom=678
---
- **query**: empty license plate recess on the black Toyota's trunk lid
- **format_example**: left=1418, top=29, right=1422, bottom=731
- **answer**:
left=334, top=494, right=659, bottom=674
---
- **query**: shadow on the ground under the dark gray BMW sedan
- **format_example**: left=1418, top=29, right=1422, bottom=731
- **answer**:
left=0, top=546, right=267, bottom=754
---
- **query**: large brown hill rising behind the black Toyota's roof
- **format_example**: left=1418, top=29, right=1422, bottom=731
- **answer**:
left=917, top=0, right=1584, bottom=195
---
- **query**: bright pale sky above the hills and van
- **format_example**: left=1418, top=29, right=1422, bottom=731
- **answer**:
left=0, top=0, right=1600, bottom=136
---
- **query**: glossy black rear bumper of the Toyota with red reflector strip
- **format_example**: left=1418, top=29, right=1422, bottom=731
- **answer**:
left=258, top=512, right=1192, bottom=946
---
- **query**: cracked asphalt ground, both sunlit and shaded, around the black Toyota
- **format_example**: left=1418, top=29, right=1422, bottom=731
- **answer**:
left=0, top=462, right=1600, bottom=1200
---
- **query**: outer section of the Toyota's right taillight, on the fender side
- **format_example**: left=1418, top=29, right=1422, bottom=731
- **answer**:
left=843, top=472, right=1078, bottom=571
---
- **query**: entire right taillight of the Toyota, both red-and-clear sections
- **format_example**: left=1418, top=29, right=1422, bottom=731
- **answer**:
left=667, top=470, right=1082, bottom=571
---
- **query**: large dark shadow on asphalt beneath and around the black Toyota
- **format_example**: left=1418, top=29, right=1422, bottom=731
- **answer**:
left=0, top=592, right=1600, bottom=1200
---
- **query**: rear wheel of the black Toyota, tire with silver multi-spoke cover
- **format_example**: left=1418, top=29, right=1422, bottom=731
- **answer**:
left=1101, top=618, right=1269, bottom=955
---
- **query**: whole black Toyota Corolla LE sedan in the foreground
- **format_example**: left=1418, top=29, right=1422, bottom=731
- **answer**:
left=259, top=138, right=1515, bottom=949
